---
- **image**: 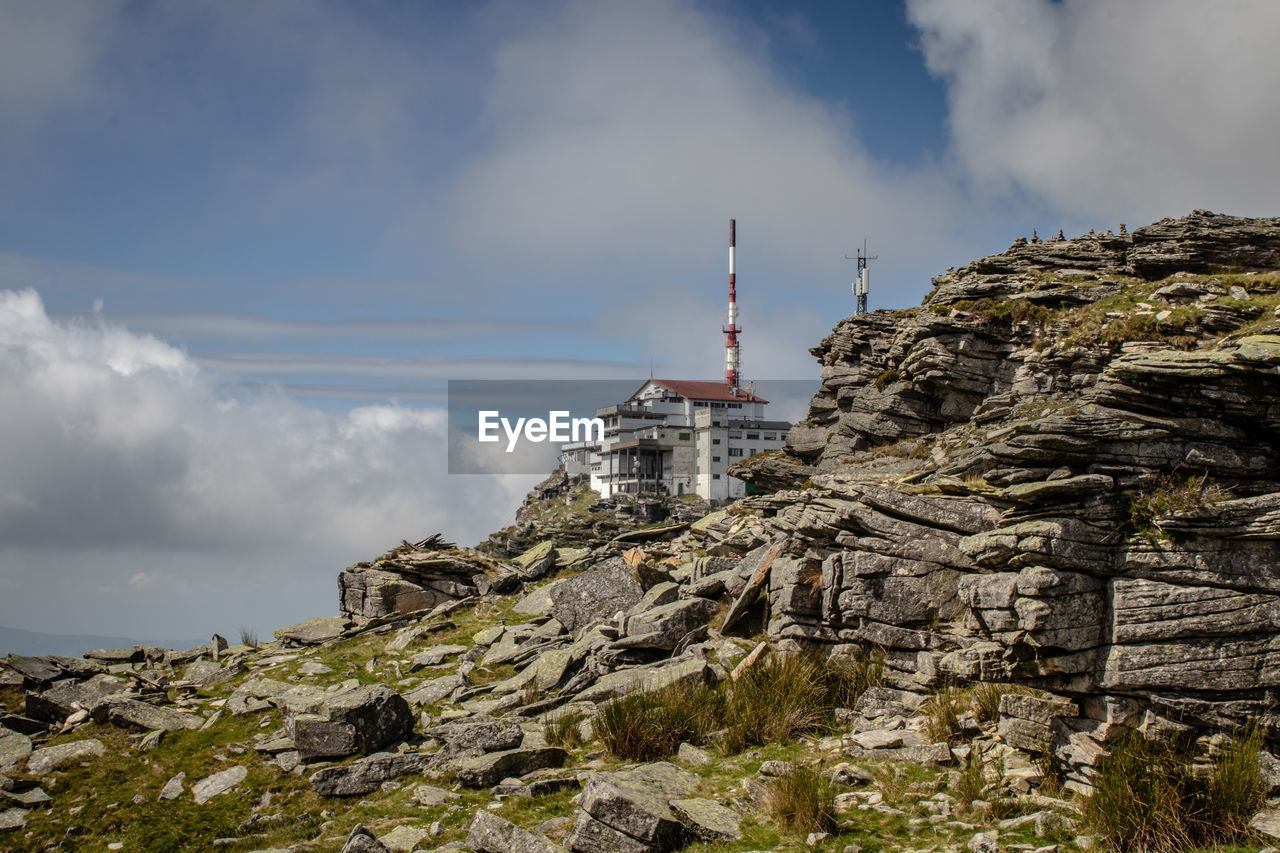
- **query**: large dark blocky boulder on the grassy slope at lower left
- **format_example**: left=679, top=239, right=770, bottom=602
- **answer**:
left=284, top=684, right=413, bottom=761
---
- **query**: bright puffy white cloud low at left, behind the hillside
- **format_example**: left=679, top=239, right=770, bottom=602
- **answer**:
left=0, top=291, right=538, bottom=638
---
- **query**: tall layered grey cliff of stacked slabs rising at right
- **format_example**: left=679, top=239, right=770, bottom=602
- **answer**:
left=727, top=211, right=1280, bottom=737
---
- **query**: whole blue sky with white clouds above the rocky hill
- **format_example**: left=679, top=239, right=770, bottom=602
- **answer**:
left=0, top=0, right=1280, bottom=639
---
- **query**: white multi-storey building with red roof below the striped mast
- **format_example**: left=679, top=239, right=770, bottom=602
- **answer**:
left=561, top=379, right=791, bottom=502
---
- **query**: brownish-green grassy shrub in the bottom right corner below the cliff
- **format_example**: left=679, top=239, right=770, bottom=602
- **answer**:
left=1084, top=730, right=1266, bottom=853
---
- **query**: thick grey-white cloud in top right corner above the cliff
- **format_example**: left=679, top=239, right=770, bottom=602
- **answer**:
left=908, top=0, right=1280, bottom=227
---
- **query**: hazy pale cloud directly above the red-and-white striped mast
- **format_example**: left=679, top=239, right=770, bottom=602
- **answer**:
left=437, top=0, right=950, bottom=280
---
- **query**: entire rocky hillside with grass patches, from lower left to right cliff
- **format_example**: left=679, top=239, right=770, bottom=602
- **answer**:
left=0, top=211, right=1280, bottom=853
